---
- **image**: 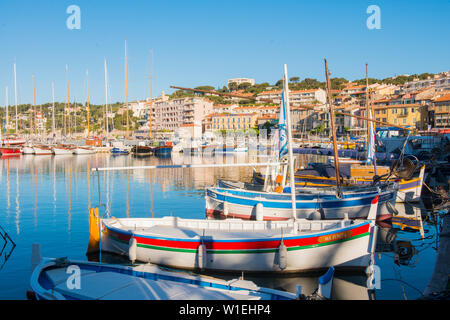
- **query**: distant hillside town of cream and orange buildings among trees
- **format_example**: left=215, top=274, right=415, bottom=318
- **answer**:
left=0, top=72, right=450, bottom=137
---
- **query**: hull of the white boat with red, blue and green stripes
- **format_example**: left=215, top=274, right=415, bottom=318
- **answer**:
left=101, top=218, right=376, bottom=273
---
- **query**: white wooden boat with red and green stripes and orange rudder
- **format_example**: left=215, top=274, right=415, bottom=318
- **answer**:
left=93, top=196, right=378, bottom=273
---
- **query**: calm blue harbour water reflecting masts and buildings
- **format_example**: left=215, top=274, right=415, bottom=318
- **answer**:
left=0, top=154, right=442, bottom=299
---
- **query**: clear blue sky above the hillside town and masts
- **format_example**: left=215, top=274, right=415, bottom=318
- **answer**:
left=0, top=0, right=450, bottom=106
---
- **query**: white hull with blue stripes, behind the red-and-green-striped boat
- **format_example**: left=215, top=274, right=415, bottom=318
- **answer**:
left=205, top=188, right=396, bottom=221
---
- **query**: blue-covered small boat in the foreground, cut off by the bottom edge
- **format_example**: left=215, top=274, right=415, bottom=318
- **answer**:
left=27, top=245, right=314, bottom=300
